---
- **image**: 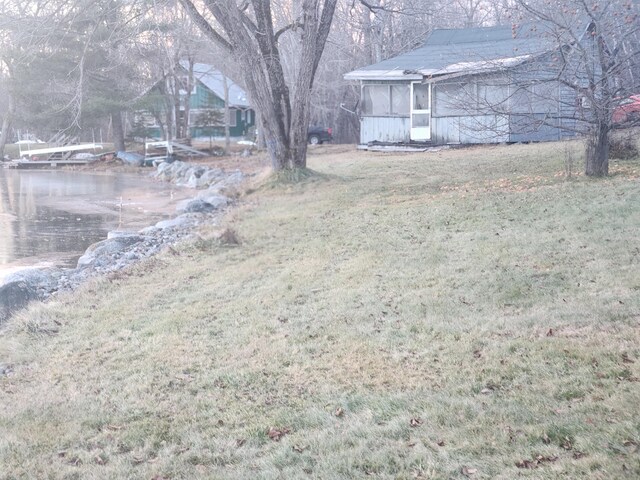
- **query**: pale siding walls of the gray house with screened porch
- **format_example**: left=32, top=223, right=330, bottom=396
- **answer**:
left=360, top=54, right=580, bottom=144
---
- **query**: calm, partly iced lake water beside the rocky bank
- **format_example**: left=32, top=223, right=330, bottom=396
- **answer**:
left=0, top=167, right=188, bottom=281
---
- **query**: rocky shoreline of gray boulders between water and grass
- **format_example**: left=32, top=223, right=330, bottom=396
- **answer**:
left=0, top=161, right=244, bottom=325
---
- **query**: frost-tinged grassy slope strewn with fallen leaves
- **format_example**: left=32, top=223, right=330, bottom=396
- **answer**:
left=0, top=144, right=640, bottom=479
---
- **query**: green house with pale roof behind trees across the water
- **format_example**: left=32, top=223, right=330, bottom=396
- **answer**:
left=136, top=63, right=256, bottom=138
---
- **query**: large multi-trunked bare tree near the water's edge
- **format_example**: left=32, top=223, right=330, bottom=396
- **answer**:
left=180, top=0, right=337, bottom=171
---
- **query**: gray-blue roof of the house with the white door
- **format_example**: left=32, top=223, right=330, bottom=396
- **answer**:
left=344, top=23, right=556, bottom=80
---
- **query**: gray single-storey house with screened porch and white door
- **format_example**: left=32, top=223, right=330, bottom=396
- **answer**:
left=345, top=24, right=581, bottom=144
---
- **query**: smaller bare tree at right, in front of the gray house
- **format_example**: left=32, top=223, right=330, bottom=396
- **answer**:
left=518, top=0, right=640, bottom=176
